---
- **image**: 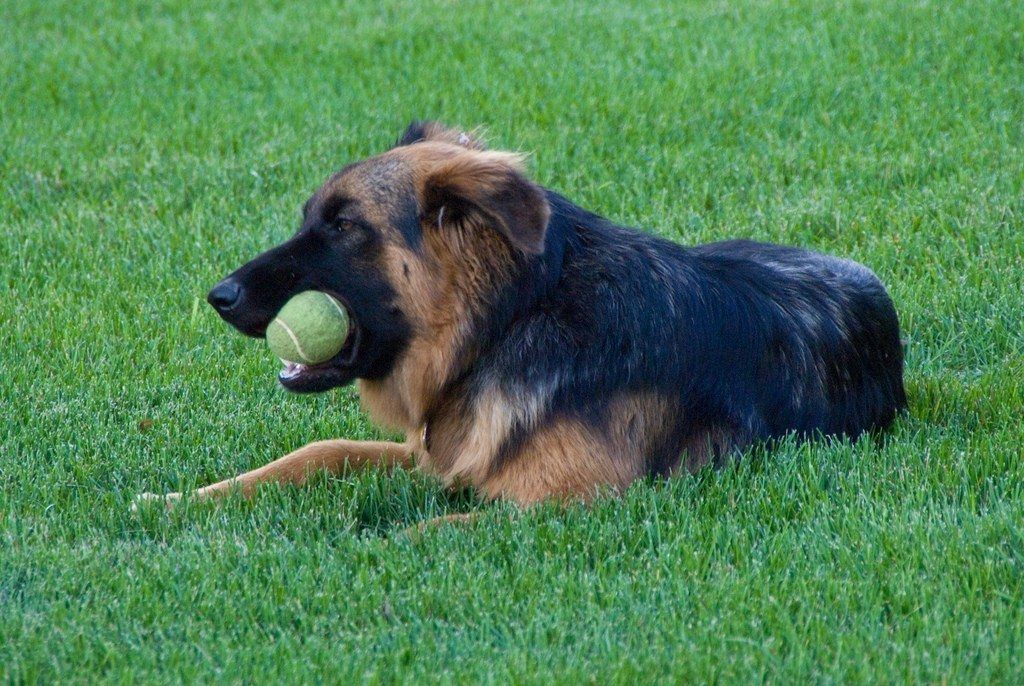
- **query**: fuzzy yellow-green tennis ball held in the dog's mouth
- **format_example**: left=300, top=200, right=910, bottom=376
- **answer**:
left=266, top=291, right=348, bottom=365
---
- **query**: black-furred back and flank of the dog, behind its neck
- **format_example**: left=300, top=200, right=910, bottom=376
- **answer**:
left=478, top=194, right=906, bottom=481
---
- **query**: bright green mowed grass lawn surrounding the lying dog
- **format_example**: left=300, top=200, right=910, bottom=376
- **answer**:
left=0, top=0, right=1024, bottom=684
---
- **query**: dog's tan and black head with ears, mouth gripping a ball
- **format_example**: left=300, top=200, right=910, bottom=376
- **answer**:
left=202, top=123, right=550, bottom=392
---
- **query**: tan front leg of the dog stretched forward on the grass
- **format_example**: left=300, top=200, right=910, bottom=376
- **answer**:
left=132, top=439, right=416, bottom=509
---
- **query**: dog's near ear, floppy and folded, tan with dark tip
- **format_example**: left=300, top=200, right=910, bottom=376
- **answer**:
left=423, top=153, right=551, bottom=255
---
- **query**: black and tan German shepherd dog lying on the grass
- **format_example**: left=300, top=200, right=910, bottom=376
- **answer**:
left=134, top=122, right=906, bottom=516
